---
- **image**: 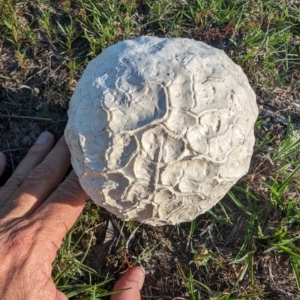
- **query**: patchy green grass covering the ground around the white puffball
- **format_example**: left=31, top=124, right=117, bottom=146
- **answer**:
left=0, top=0, right=300, bottom=300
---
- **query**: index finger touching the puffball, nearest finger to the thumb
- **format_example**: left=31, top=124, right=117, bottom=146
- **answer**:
left=33, top=171, right=88, bottom=254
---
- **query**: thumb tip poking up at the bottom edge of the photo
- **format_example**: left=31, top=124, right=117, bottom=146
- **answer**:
left=110, top=267, right=145, bottom=300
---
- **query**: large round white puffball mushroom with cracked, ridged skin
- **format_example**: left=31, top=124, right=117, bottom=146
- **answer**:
left=65, top=37, right=258, bottom=225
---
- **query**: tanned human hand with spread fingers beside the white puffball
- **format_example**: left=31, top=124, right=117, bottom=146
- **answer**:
left=0, top=132, right=144, bottom=300
